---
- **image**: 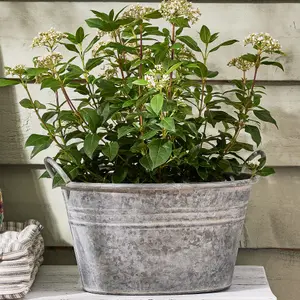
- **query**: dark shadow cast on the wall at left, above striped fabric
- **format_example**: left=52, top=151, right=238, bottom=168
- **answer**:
left=0, top=48, right=66, bottom=245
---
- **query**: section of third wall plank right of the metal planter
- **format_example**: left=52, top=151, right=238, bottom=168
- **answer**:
left=242, top=167, right=300, bottom=249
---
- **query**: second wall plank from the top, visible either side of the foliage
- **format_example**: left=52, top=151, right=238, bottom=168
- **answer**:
left=0, top=85, right=300, bottom=166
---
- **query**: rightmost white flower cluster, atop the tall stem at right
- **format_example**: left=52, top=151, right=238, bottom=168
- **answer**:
left=244, top=32, right=282, bottom=53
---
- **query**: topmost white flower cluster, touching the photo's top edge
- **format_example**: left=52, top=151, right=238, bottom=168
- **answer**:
left=159, top=0, right=201, bottom=24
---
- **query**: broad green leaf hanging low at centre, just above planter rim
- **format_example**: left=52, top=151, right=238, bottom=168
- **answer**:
left=149, top=139, right=172, bottom=169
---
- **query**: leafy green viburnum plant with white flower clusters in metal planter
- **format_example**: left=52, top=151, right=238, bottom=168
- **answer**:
left=0, top=0, right=283, bottom=185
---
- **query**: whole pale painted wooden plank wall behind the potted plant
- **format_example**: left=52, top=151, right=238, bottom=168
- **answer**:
left=0, top=0, right=300, bottom=300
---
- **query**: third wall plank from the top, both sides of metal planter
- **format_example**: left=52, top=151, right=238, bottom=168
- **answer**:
left=0, top=166, right=300, bottom=248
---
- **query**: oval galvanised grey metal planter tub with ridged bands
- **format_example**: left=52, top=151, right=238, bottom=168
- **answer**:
left=45, top=158, right=255, bottom=295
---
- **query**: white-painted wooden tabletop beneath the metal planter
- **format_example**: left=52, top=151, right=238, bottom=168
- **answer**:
left=24, top=266, right=276, bottom=300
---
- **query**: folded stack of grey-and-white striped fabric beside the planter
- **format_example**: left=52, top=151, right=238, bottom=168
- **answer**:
left=0, top=220, right=44, bottom=300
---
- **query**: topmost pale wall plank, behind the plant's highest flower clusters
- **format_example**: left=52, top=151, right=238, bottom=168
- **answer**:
left=0, top=1, right=300, bottom=80
